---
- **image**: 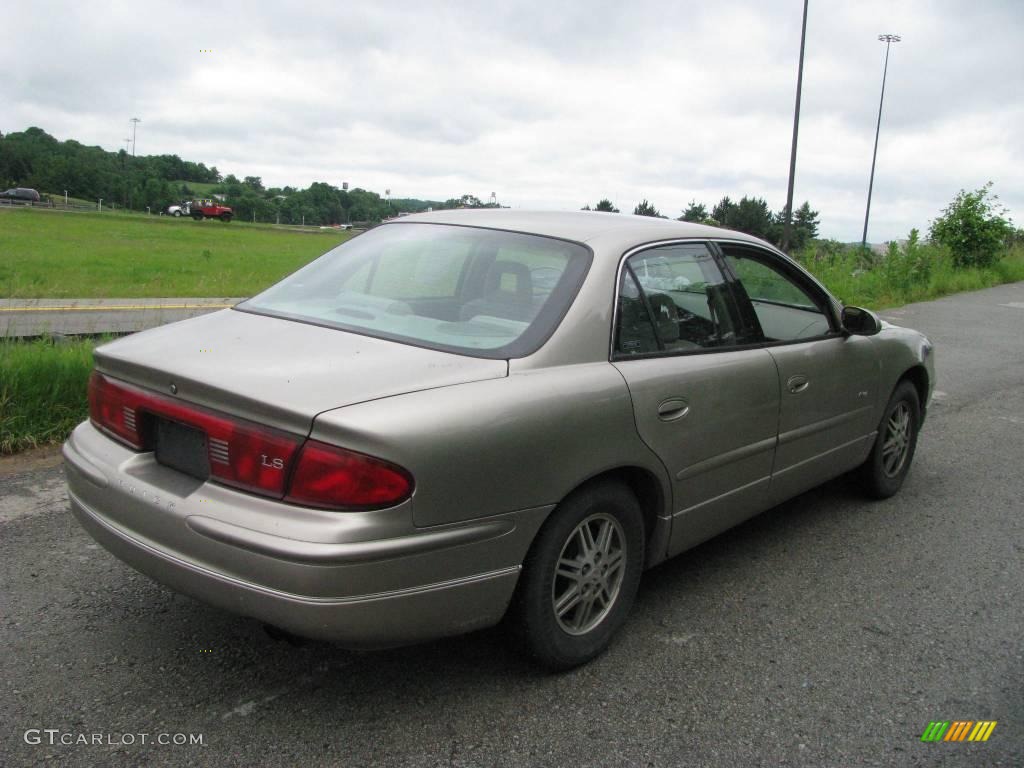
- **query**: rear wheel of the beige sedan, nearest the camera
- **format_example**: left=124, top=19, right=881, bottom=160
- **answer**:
left=512, top=480, right=644, bottom=670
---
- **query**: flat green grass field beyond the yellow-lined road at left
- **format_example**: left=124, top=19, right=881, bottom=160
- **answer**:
left=0, top=209, right=350, bottom=299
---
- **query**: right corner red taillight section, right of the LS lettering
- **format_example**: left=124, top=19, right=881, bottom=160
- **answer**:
left=285, top=440, right=413, bottom=509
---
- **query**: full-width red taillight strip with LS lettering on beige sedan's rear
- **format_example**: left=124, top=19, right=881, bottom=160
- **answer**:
left=89, top=373, right=413, bottom=509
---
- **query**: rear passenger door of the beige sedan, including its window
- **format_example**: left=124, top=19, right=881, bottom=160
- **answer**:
left=612, top=243, right=779, bottom=554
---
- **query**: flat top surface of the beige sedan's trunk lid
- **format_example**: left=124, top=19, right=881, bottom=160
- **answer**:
left=95, top=309, right=508, bottom=434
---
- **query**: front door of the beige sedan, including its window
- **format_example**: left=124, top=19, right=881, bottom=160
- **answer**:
left=720, top=243, right=879, bottom=503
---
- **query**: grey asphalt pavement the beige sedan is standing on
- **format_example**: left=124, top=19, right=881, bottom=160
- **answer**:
left=0, top=284, right=1024, bottom=768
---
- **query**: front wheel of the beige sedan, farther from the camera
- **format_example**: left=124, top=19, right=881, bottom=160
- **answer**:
left=860, top=381, right=921, bottom=499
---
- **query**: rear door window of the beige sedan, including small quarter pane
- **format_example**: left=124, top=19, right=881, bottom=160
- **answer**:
left=615, top=243, right=743, bottom=357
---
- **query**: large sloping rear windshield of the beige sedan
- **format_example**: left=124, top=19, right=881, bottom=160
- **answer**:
left=236, top=223, right=591, bottom=358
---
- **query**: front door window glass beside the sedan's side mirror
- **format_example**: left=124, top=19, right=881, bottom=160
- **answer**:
left=722, top=245, right=831, bottom=342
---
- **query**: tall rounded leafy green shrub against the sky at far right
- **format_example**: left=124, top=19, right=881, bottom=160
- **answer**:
left=930, top=181, right=1014, bottom=268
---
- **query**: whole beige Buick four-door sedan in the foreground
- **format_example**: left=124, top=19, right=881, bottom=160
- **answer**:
left=63, top=210, right=935, bottom=669
